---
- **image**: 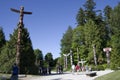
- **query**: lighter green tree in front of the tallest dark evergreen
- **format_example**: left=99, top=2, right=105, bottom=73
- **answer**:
left=84, top=20, right=105, bottom=63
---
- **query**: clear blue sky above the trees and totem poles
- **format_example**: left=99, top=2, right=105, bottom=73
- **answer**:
left=0, top=0, right=120, bottom=58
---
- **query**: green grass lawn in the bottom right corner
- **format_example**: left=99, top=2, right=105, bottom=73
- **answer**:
left=94, top=70, right=120, bottom=80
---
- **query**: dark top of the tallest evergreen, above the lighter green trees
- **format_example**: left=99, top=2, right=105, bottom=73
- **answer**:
left=76, top=0, right=97, bottom=26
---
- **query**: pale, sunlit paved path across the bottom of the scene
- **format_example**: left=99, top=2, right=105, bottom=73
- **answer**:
left=20, top=70, right=113, bottom=80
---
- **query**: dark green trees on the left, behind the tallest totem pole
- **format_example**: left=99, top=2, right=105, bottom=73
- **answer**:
left=0, top=26, right=55, bottom=74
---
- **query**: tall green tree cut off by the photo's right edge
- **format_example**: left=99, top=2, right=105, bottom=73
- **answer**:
left=110, top=3, right=120, bottom=69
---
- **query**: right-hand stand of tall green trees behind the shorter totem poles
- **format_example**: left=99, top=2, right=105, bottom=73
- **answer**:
left=61, top=0, right=120, bottom=69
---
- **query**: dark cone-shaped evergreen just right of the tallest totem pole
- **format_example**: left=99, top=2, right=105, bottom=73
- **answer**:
left=17, top=27, right=37, bottom=74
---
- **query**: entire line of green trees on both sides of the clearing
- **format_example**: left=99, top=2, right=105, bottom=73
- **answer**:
left=0, top=0, right=120, bottom=74
